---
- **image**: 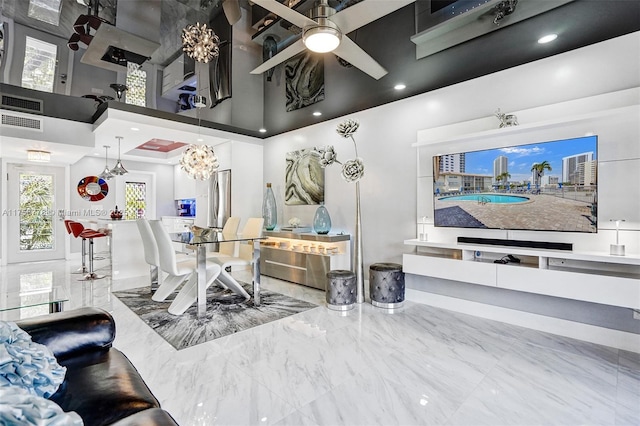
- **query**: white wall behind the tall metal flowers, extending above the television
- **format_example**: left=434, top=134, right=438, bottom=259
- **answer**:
left=264, top=33, right=640, bottom=270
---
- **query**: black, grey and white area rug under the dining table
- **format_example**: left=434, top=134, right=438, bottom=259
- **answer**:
left=113, top=283, right=317, bottom=350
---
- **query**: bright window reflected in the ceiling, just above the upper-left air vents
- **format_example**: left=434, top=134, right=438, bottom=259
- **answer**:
left=22, top=36, right=58, bottom=92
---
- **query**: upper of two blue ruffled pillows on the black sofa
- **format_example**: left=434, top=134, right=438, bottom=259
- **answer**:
left=0, top=321, right=67, bottom=398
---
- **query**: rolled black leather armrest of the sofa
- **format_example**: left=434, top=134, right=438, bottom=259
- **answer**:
left=16, top=308, right=116, bottom=360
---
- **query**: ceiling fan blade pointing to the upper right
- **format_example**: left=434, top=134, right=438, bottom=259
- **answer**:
left=329, top=0, right=415, bottom=34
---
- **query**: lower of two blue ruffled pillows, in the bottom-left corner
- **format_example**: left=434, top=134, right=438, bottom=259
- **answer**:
left=0, top=387, right=83, bottom=426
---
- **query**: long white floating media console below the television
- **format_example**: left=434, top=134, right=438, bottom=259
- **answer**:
left=403, top=239, right=640, bottom=310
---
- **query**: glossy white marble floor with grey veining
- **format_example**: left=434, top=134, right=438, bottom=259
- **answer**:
left=0, top=261, right=640, bottom=426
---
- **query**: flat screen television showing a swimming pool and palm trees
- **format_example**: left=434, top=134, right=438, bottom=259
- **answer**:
left=433, top=136, right=598, bottom=233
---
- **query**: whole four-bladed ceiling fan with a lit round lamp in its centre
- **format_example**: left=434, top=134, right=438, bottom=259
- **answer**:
left=251, top=0, right=415, bottom=80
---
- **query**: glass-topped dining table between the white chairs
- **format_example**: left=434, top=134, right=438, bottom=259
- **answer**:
left=169, top=228, right=267, bottom=316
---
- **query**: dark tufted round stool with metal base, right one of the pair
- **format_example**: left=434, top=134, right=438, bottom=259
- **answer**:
left=369, top=263, right=404, bottom=309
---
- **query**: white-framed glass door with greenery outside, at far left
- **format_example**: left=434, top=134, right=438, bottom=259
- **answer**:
left=4, top=164, right=65, bottom=263
